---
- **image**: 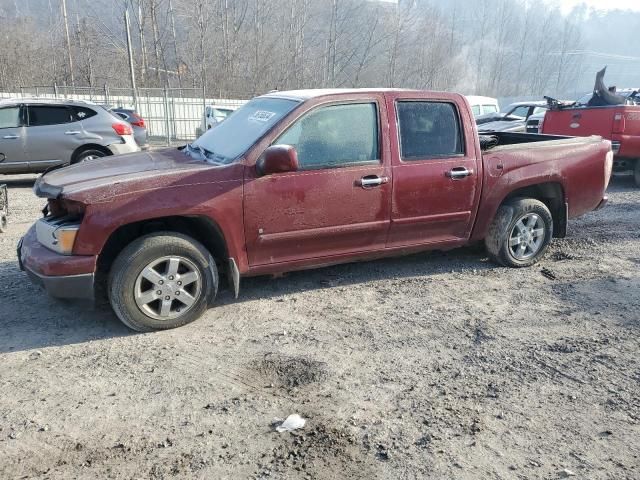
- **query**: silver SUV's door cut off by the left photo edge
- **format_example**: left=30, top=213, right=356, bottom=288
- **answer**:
left=0, top=105, right=28, bottom=173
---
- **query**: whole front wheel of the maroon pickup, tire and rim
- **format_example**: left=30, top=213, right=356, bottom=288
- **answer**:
left=109, top=232, right=218, bottom=332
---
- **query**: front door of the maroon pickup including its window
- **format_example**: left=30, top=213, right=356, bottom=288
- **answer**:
left=244, top=97, right=391, bottom=267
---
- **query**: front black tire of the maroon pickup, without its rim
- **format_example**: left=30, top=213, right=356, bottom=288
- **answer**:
left=108, top=232, right=218, bottom=332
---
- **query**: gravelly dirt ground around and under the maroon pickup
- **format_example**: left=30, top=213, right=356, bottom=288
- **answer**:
left=0, top=173, right=640, bottom=479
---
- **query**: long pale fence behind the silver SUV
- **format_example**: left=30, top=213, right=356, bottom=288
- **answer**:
left=0, top=85, right=254, bottom=145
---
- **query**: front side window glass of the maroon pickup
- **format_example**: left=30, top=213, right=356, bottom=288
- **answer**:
left=274, top=103, right=380, bottom=170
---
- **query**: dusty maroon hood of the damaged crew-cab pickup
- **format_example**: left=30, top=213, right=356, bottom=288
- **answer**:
left=33, top=148, right=224, bottom=203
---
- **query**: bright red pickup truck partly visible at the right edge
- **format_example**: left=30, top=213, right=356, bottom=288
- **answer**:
left=541, top=85, right=640, bottom=187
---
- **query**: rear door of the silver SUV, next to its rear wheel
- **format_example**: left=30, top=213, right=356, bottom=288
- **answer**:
left=26, top=105, right=85, bottom=172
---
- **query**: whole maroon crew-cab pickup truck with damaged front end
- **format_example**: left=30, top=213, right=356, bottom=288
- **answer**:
left=18, top=89, right=613, bottom=331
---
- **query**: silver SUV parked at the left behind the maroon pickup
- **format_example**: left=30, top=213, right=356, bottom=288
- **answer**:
left=0, top=98, right=140, bottom=174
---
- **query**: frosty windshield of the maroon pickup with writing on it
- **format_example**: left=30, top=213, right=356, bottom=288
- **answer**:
left=187, top=98, right=299, bottom=164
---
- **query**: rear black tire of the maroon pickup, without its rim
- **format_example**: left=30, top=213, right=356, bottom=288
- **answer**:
left=485, top=198, right=553, bottom=268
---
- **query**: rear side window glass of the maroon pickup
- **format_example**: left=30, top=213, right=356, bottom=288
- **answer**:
left=397, top=101, right=464, bottom=160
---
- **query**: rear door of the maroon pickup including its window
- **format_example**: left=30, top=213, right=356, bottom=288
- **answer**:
left=387, top=93, right=482, bottom=247
